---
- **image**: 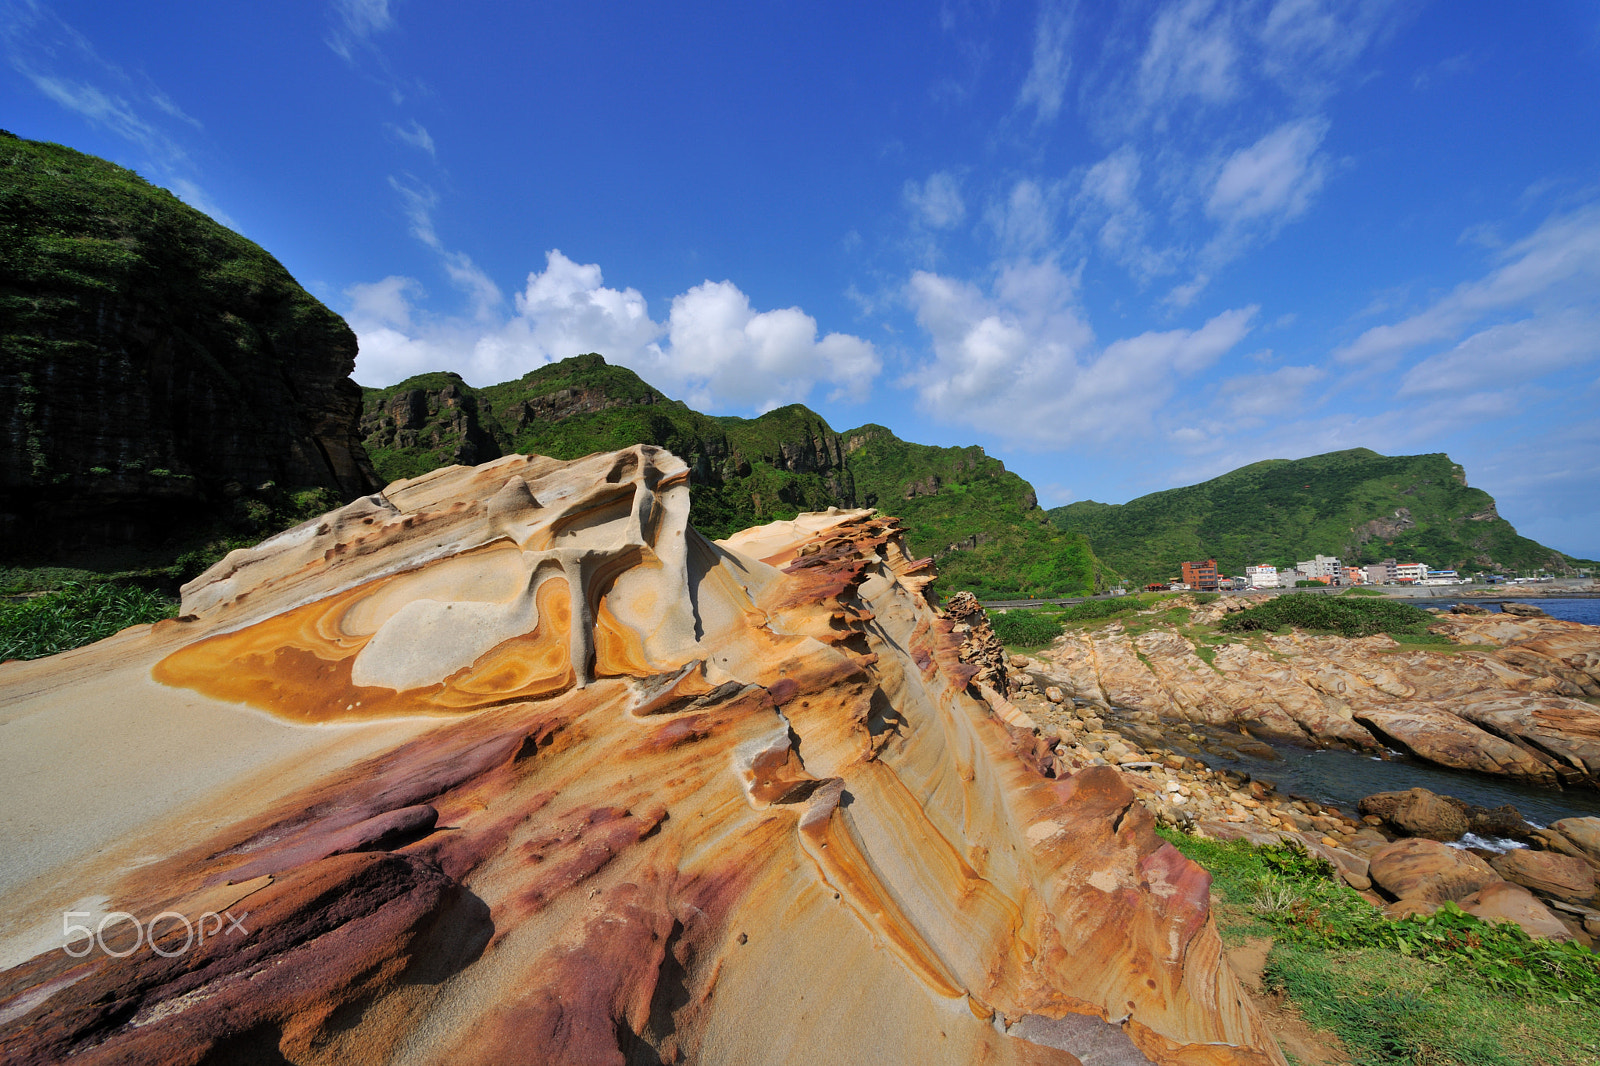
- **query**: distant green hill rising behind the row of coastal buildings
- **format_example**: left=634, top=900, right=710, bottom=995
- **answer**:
left=1050, top=448, right=1584, bottom=583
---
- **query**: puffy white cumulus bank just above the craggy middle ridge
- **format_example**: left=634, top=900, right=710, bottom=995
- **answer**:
left=346, top=250, right=882, bottom=410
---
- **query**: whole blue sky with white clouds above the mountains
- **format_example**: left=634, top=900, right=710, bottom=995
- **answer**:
left=0, top=0, right=1600, bottom=562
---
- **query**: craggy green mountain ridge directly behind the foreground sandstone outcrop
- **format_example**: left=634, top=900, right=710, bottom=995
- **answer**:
left=362, top=354, right=1106, bottom=595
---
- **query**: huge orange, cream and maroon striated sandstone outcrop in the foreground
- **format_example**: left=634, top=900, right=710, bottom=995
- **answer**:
left=0, top=447, right=1283, bottom=1066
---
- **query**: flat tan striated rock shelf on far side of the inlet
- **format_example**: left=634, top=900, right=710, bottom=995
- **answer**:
left=1042, top=597, right=1600, bottom=787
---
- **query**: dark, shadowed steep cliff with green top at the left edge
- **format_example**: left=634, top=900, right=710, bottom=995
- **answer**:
left=0, top=134, right=378, bottom=547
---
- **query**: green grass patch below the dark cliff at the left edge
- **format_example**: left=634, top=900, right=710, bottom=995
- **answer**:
left=0, top=583, right=178, bottom=661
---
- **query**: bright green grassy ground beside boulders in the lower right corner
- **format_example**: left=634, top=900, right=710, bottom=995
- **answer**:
left=1162, top=829, right=1600, bottom=1066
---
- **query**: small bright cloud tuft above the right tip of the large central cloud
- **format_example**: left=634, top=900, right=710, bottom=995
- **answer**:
left=1206, top=117, right=1328, bottom=226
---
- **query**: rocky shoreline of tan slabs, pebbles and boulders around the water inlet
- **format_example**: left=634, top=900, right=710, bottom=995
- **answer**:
left=950, top=599, right=1600, bottom=948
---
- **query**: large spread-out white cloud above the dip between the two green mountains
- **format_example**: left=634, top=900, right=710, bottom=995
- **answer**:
left=902, top=261, right=1256, bottom=448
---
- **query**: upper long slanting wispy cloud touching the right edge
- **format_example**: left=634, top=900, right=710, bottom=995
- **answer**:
left=1336, top=205, right=1600, bottom=363
